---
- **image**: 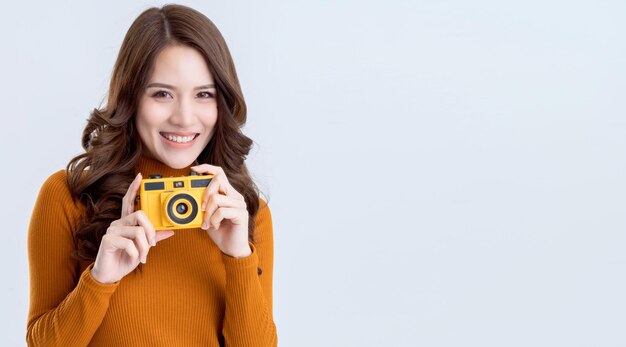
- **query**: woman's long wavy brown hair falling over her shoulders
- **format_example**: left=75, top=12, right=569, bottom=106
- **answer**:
left=66, top=5, right=259, bottom=260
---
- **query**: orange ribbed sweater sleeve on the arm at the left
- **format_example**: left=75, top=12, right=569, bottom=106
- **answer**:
left=26, top=170, right=119, bottom=346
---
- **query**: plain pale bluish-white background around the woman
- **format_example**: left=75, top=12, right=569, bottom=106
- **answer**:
left=0, top=0, right=626, bottom=347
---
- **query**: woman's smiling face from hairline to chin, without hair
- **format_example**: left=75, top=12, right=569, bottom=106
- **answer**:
left=135, top=46, right=217, bottom=169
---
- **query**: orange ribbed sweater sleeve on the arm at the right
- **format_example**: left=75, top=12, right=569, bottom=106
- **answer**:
left=222, top=199, right=278, bottom=347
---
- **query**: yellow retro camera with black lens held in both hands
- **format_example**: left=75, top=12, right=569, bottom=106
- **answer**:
left=139, top=171, right=213, bottom=230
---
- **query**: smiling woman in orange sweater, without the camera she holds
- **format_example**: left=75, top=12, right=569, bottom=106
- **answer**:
left=27, top=5, right=277, bottom=346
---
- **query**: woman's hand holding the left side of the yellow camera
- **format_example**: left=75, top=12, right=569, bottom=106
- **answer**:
left=91, top=174, right=174, bottom=284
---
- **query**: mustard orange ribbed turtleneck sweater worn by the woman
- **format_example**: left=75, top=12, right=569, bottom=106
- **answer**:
left=26, top=158, right=277, bottom=347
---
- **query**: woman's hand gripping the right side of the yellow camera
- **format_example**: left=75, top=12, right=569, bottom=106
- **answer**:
left=191, top=164, right=252, bottom=258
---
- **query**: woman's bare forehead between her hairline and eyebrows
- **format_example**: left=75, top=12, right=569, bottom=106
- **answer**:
left=150, top=45, right=213, bottom=87
